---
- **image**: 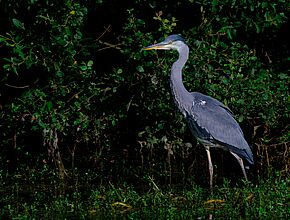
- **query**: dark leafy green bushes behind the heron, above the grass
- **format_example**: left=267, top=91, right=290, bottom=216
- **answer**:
left=0, top=0, right=290, bottom=183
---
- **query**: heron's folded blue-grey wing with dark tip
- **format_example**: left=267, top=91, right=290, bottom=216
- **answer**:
left=188, top=92, right=253, bottom=164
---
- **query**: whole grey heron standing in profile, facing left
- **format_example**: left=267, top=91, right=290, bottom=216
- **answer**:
left=144, top=35, right=254, bottom=188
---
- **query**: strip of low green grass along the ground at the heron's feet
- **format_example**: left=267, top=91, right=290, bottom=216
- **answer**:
left=0, top=168, right=290, bottom=219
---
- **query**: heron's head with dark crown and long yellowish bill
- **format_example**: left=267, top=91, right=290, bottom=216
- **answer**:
left=144, top=34, right=185, bottom=50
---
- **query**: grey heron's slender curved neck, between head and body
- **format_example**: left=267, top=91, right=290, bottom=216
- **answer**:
left=170, top=44, right=191, bottom=110
